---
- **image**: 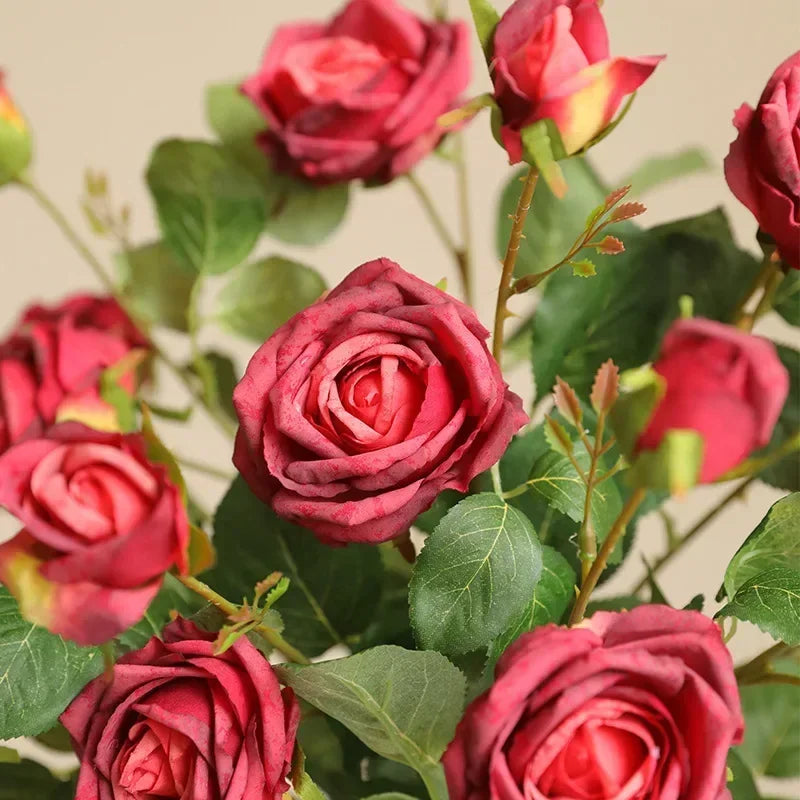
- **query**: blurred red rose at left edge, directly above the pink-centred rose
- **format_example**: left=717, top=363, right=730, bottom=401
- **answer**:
left=0, top=295, right=149, bottom=453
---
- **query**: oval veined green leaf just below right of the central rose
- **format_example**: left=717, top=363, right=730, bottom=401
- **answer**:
left=409, top=493, right=542, bottom=654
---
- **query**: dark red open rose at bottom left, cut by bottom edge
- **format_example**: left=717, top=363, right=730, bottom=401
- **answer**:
left=61, top=619, right=300, bottom=800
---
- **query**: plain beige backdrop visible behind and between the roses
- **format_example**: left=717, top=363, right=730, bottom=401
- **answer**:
left=0, top=0, right=800, bottom=788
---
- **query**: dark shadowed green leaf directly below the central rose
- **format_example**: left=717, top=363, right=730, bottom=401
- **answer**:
left=204, top=477, right=383, bottom=656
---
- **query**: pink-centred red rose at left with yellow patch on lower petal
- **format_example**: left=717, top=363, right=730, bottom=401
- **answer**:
left=0, top=422, right=189, bottom=644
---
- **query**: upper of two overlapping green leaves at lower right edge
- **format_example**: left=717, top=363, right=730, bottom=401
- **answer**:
left=725, top=492, right=800, bottom=597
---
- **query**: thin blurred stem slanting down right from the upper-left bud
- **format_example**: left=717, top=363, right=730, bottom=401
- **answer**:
left=17, top=177, right=236, bottom=436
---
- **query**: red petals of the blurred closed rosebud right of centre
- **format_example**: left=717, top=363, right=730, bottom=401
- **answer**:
left=637, top=319, right=789, bottom=483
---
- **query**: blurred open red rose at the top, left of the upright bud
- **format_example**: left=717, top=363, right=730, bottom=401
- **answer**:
left=242, top=0, right=470, bottom=183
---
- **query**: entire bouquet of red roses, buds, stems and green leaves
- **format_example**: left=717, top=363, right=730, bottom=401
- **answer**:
left=0, top=0, right=800, bottom=800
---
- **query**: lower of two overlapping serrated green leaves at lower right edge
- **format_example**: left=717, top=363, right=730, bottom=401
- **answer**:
left=717, top=567, right=800, bottom=645
